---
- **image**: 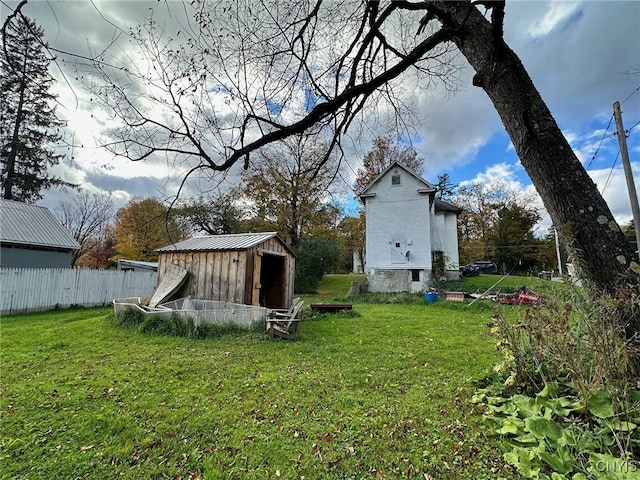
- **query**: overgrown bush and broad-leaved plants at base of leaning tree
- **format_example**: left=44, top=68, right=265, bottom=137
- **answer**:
left=475, top=282, right=640, bottom=480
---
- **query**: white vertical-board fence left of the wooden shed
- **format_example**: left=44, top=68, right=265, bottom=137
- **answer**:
left=0, top=268, right=158, bottom=315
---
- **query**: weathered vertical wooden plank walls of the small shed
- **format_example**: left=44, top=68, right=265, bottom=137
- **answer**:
left=158, top=237, right=295, bottom=307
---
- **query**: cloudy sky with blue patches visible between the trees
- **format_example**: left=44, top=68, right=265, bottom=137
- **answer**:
left=0, top=0, right=640, bottom=232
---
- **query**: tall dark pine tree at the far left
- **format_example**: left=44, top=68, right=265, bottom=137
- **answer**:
left=0, top=11, right=75, bottom=203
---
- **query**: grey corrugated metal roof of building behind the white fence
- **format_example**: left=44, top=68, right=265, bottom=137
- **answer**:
left=0, top=200, right=80, bottom=250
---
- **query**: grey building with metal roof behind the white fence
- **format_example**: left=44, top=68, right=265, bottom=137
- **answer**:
left=0, top=200, right=80, bottom=268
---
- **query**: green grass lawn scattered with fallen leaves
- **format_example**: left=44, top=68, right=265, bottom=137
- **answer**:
left=0, top=276, right=552, bottom=480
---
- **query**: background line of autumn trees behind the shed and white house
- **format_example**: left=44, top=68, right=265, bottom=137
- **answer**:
left=55, top=133, right=632, bottom=291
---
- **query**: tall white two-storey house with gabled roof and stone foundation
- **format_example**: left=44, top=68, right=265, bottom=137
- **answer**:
left=360, top=162, right=461, bottom=293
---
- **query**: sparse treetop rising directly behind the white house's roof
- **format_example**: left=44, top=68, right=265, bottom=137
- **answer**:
left=353, top=137, right=424, bottom=199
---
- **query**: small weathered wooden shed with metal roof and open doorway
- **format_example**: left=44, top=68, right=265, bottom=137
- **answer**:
left=158, top=232, right=295, bottom=308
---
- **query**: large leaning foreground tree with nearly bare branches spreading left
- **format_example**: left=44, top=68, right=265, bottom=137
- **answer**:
left=82, top=0, right=640, bottom=300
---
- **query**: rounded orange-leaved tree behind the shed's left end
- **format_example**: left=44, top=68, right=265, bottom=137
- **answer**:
left=113, top=198, right=184, bottom=261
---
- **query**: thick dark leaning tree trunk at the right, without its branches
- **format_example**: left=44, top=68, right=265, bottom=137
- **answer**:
left=428, top=2, right=637, bottom=294
